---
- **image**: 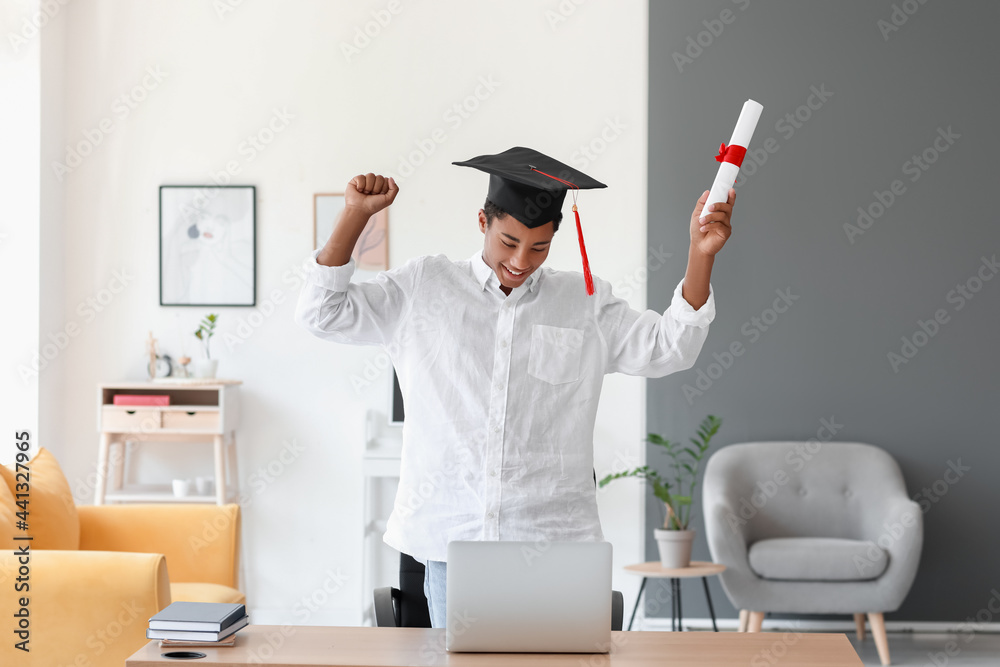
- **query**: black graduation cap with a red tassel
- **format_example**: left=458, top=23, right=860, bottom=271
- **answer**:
left=452, top=146, right=607, bottom=295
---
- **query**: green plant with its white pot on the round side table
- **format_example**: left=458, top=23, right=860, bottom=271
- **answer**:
left=600, top=415, right=722, bottom=568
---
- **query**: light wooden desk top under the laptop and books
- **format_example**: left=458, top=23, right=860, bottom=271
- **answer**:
left=125, top=625, right=862, bottom=667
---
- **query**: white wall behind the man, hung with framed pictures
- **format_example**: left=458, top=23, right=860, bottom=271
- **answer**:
left=39, top=0, right=652, bottom=624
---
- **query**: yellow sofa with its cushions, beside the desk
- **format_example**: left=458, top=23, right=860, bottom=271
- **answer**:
left=0, top=448, right=246, bottom=667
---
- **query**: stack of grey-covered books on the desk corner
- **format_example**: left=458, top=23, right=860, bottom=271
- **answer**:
left=146, top=602, right=250, bottom=646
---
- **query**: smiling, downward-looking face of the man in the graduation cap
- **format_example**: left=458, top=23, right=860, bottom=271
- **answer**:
left=479, top=210, right=556, bottom=294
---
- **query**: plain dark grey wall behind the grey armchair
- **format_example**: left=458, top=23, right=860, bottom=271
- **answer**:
left=647, top=0, right=1000, bottom=621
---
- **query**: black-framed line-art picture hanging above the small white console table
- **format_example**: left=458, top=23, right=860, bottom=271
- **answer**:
left=160, top=185, right=257, bottom=306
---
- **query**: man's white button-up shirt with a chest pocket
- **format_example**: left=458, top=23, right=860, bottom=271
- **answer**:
left=295, top=251, right=715, bottom=562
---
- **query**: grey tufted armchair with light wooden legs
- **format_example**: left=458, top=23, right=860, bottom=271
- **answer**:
left=703, top=440, right=923, bottom=665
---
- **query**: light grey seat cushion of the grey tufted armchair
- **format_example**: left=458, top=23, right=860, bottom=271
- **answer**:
left=749, top=537, right=889, bottom=581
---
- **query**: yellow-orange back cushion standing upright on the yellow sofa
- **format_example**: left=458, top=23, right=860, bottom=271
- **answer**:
left=0, top=447, right=80, bottom=549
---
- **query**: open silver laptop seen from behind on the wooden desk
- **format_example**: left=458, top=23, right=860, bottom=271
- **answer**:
left=445, top=541, right=611, bottom=653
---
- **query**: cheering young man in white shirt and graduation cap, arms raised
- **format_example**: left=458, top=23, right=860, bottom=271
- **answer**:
left=296, top=148, right=736, bottom=627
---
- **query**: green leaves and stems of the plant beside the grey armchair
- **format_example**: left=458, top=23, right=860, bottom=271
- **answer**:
left=599, top=415, right=722, bottom=530
